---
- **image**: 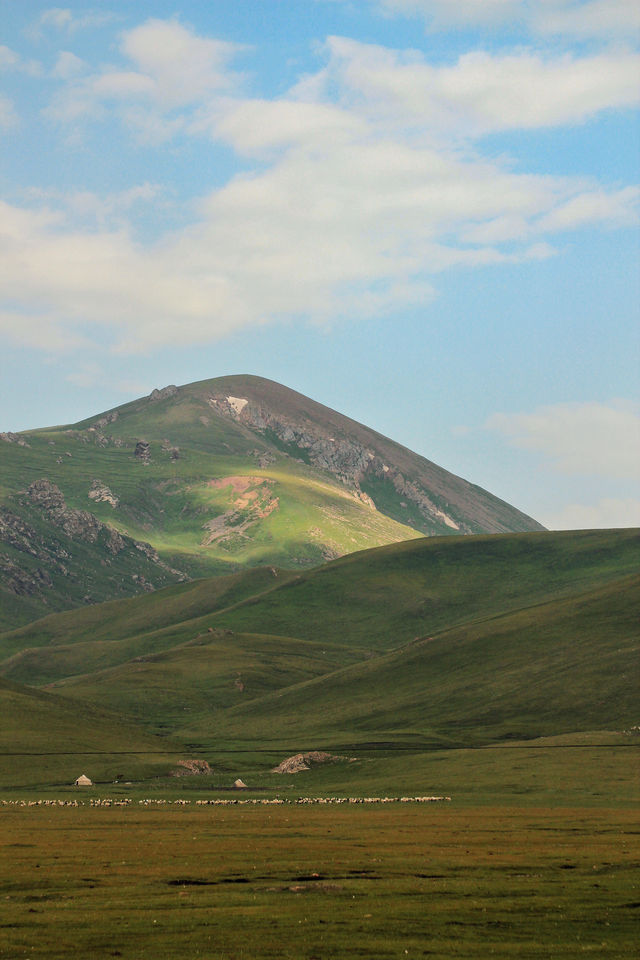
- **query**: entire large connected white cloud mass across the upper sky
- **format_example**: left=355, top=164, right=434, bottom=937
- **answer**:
left=6, top=20, right=637, bottom=350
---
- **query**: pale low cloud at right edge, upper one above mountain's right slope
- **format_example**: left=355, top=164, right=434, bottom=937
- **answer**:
left=486, top=403, right=640, bottom=479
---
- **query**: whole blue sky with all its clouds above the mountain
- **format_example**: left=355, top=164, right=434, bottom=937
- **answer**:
left=0, top=0, right=640, bottom=529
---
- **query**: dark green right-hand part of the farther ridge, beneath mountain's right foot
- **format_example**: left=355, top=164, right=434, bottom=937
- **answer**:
left=209, top=530, right=640, bottom=650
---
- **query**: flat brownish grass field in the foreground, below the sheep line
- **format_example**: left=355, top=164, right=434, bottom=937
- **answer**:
left=0, top=799, right=640, bottom=960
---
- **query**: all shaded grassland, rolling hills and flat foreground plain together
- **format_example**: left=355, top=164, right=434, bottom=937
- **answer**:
left=0, top=531, right=640, bottom=960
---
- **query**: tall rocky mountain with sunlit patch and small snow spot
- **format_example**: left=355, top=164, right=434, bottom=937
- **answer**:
left=0, top=376, right=542, bottom=627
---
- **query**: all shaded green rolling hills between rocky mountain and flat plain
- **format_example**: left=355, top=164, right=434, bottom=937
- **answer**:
left=0, top=530, right=640, bottom=757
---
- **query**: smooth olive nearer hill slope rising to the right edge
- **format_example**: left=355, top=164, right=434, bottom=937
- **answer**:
left=209, top=576, right=640, bottom=746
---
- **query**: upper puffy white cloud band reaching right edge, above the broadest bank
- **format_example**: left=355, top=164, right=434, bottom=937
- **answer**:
left=49, top=20, right=640, bottom=142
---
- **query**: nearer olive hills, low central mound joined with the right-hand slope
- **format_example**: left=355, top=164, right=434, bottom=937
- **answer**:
left=38, top=577, right=640, bottom=749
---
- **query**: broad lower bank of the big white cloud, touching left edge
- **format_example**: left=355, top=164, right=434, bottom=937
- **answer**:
left=0, top=133, right=624, bottom=358
